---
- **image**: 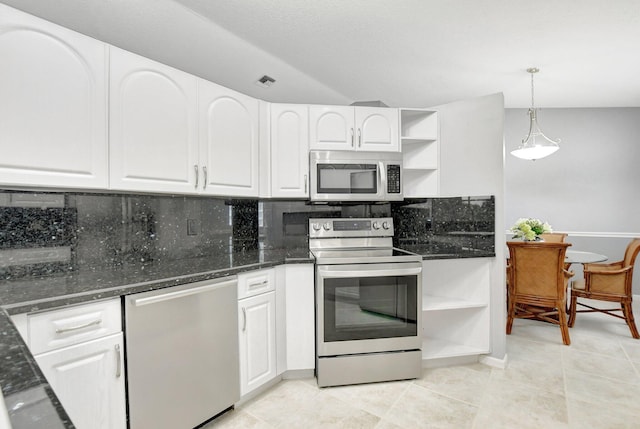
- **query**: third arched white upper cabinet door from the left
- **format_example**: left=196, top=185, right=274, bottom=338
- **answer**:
left=198, top=80, right=259, bottom=197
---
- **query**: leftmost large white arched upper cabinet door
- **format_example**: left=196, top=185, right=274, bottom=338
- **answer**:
left=0, top=4, right=108, bottom=189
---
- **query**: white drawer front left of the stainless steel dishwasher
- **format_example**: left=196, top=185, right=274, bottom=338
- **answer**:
left=28, top=298, right=122, bottom=354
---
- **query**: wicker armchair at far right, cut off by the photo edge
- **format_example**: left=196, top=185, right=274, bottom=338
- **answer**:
left=569, top=238, right=640, bottom=339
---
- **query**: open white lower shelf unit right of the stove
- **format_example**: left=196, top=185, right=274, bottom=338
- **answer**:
left=422, top=258, right=491, bottom=361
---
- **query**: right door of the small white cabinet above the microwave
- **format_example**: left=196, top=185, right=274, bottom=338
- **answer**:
left=355, top=107, right=400, bottom=152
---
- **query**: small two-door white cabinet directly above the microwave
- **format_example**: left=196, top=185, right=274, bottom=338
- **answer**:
left=309, top=106, right=400, bottom=152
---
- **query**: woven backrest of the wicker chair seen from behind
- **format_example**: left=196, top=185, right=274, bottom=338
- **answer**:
left=507, top=241, right=571, bottom=300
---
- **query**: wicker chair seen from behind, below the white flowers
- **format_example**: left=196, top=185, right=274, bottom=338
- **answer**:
left=507, top=241, right=573, bottom=345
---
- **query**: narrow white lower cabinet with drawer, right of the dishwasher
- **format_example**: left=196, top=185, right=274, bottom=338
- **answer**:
left=238, top=268, right=277, bottom=396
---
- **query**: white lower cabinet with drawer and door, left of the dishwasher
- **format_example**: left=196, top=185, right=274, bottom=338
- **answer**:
left=12, top=298, right=127, bottom=429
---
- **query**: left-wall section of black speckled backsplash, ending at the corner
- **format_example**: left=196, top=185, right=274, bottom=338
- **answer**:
left=0, top=192, right=258, bottom=278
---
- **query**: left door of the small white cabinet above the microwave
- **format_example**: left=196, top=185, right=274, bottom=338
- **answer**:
left=309, top=106, right=356, bottom=150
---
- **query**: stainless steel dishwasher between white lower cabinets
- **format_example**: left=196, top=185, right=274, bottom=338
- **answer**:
left=125, top=276, right=240, bottom=429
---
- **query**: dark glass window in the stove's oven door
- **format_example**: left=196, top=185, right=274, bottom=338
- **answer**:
left=324, top=276, right=418, bottom=342
